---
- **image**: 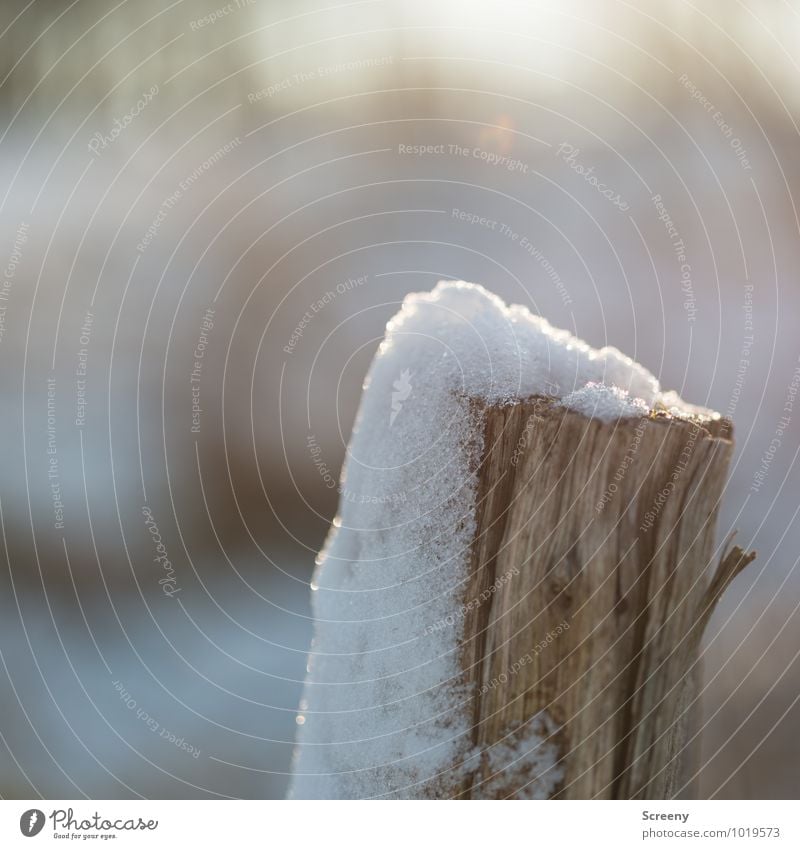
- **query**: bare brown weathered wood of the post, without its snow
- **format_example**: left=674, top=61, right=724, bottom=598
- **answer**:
left=460, top=397, right=755, bottom=799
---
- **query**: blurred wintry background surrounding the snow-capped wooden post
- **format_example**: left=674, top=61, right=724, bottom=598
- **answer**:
left=0, top=0, right=800, bottom=798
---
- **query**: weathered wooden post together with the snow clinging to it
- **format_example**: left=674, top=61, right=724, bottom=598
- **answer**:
left=292, top=284, right=753, bottom=799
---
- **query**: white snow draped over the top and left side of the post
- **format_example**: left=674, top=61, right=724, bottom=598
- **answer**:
left=291, top=282, right=714, bottom=798
